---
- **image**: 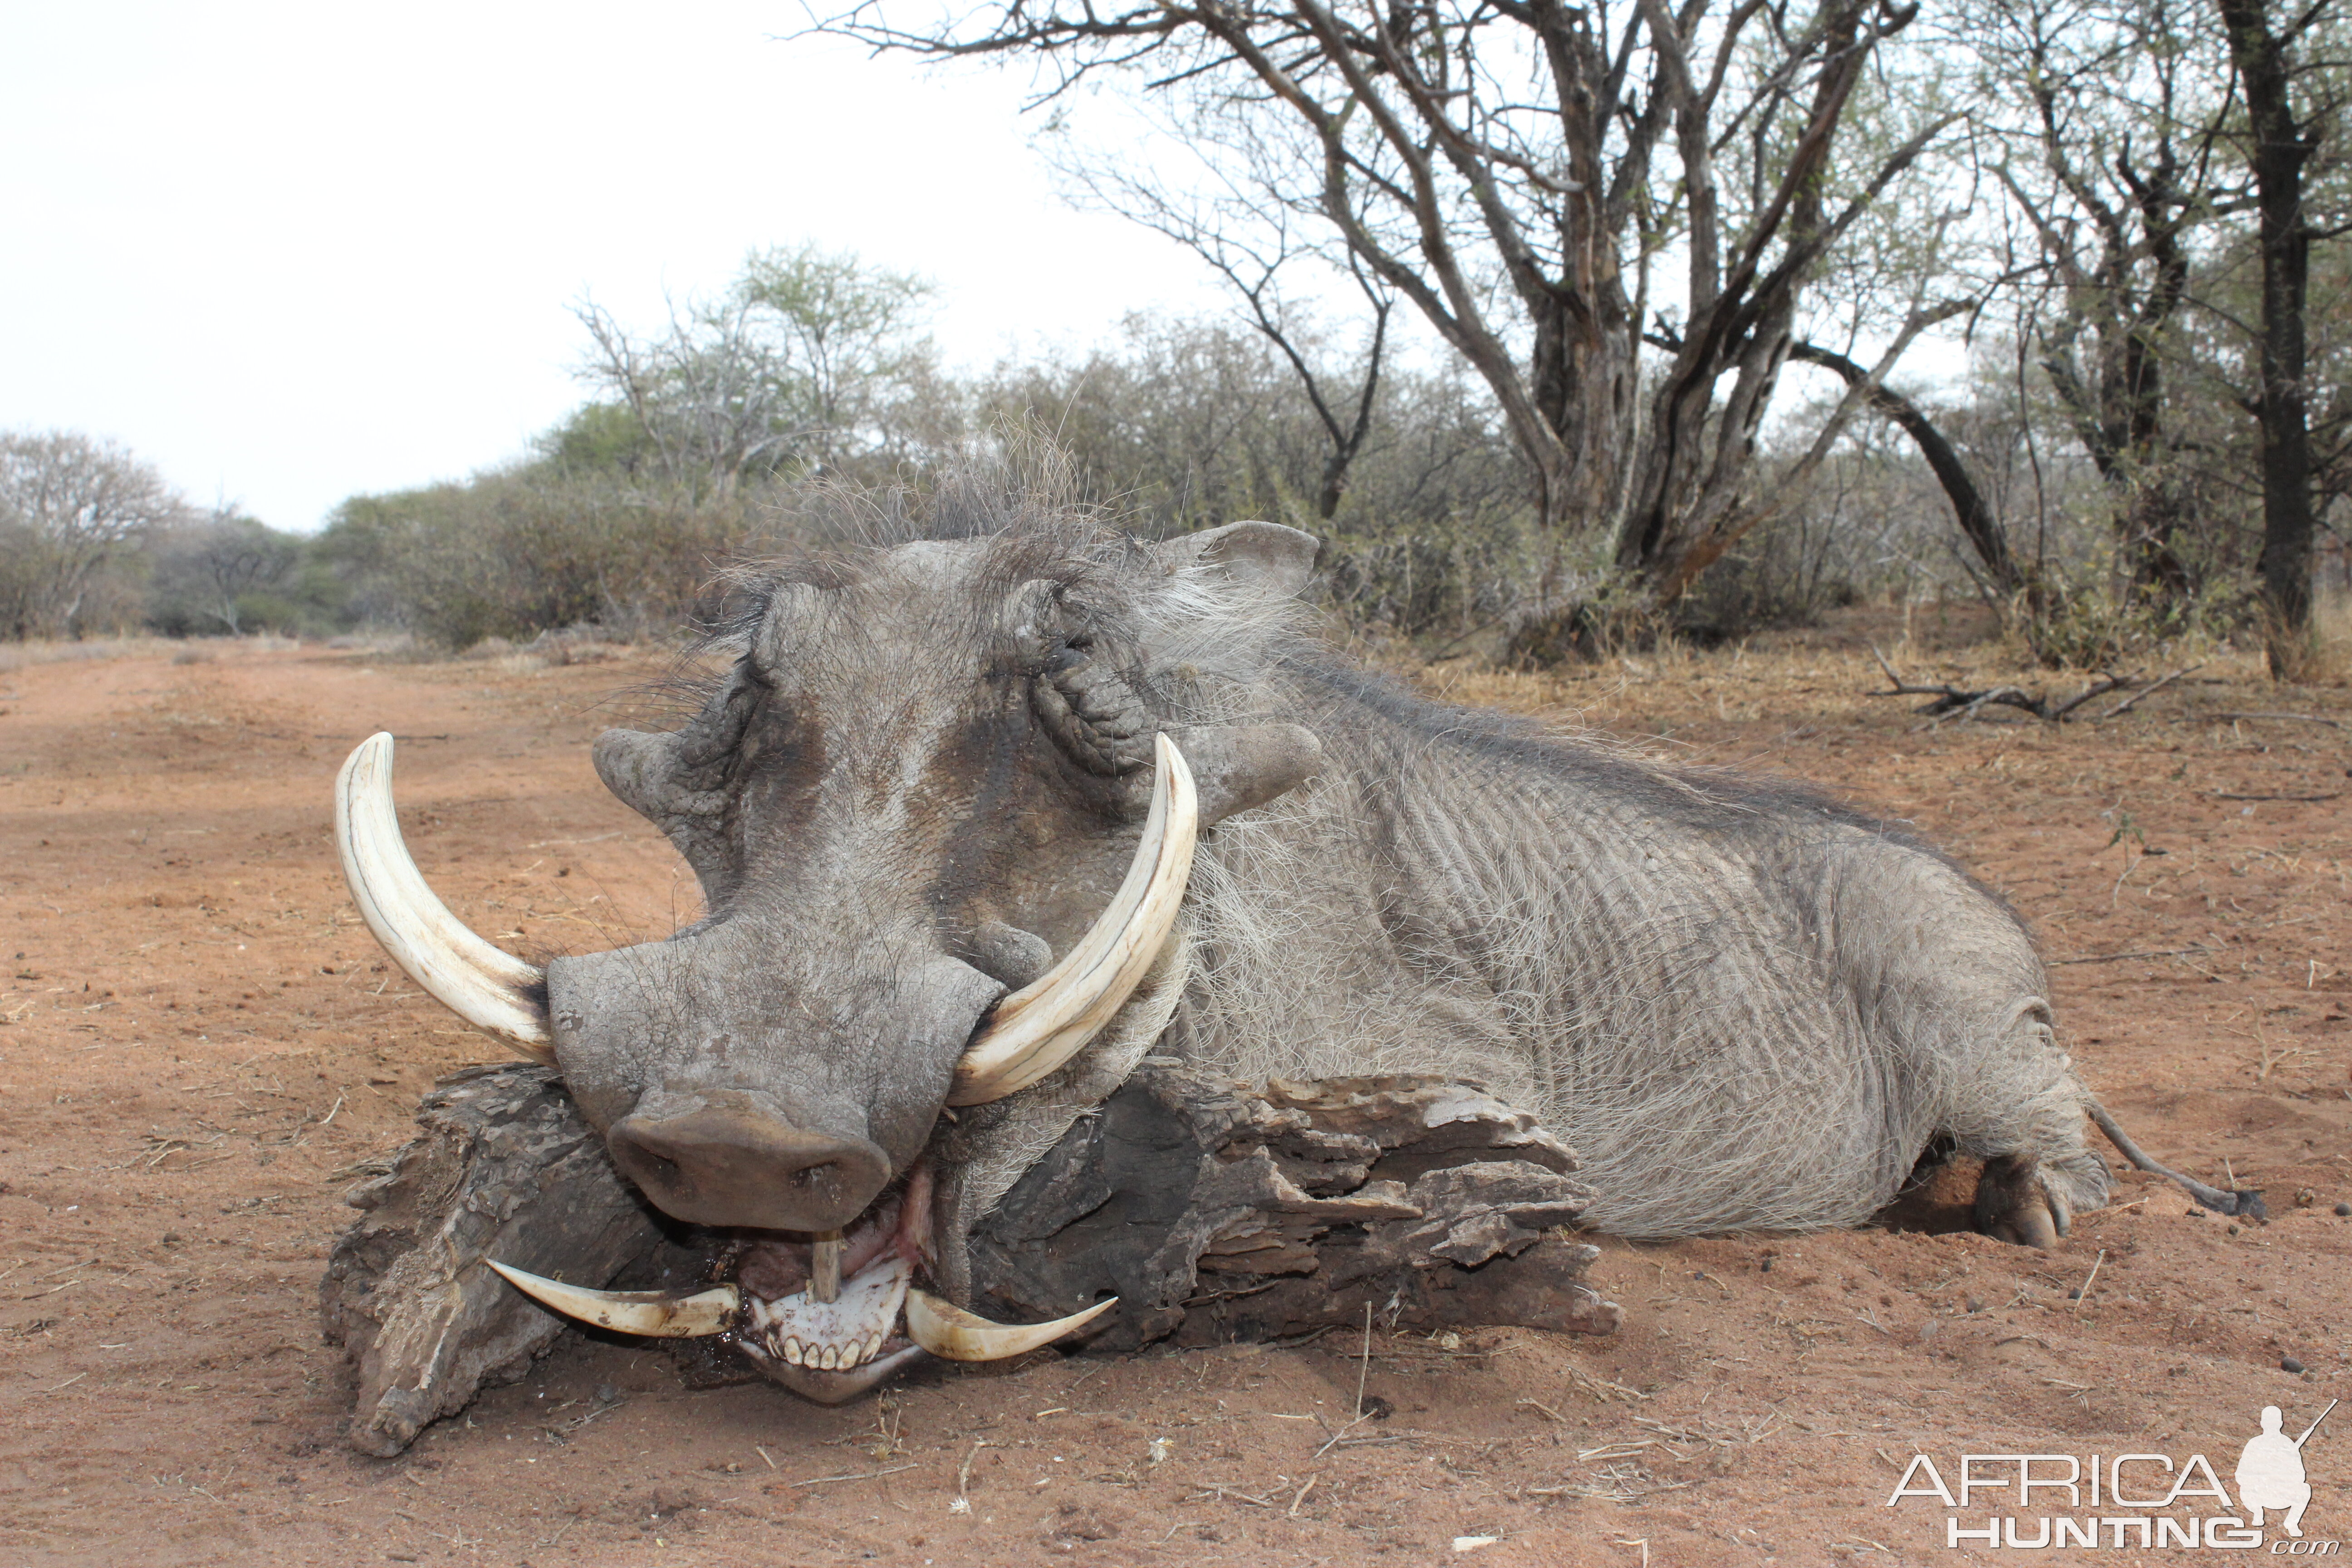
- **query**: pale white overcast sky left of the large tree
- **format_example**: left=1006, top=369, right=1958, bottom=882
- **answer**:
left=0, top=0, right=1223, bottom=529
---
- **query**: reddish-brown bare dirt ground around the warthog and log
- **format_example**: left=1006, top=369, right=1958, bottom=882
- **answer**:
left=0, top=623, right=2352, bottom=1568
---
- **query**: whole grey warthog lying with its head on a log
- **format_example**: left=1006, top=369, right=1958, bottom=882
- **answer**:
left=338, top=477, right=2239, bottom=1396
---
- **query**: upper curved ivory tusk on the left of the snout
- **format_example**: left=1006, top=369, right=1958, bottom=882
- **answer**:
left=334, top=734, right=555, bottom=1063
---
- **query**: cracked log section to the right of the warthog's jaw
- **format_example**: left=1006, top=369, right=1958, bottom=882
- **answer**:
left=971, top=1058, right=1623, bottom=1349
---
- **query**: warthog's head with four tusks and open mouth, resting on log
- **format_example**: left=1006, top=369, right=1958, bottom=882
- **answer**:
left=338, top=517, right=1319, bottom=1396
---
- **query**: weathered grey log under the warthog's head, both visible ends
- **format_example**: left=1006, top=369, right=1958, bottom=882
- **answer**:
left=320, top=1058, right=1621, bottom=1455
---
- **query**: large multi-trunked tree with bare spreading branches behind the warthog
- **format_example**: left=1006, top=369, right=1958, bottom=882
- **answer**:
left=823, top=0, right=1947, bottom=599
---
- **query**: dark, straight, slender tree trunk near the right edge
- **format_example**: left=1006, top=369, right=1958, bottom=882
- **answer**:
left=2220, top=0, right=2314, bottom=679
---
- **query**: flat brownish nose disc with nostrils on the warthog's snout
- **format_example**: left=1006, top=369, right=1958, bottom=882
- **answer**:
left=604, top=1093, right=889, bottom=1230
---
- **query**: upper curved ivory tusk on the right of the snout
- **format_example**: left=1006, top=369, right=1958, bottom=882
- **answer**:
left=948, top=734, right=1200, bottom=1105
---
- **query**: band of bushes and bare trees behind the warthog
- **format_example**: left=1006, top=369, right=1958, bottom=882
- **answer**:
left=14, top=0, right=2352, bottom=679
